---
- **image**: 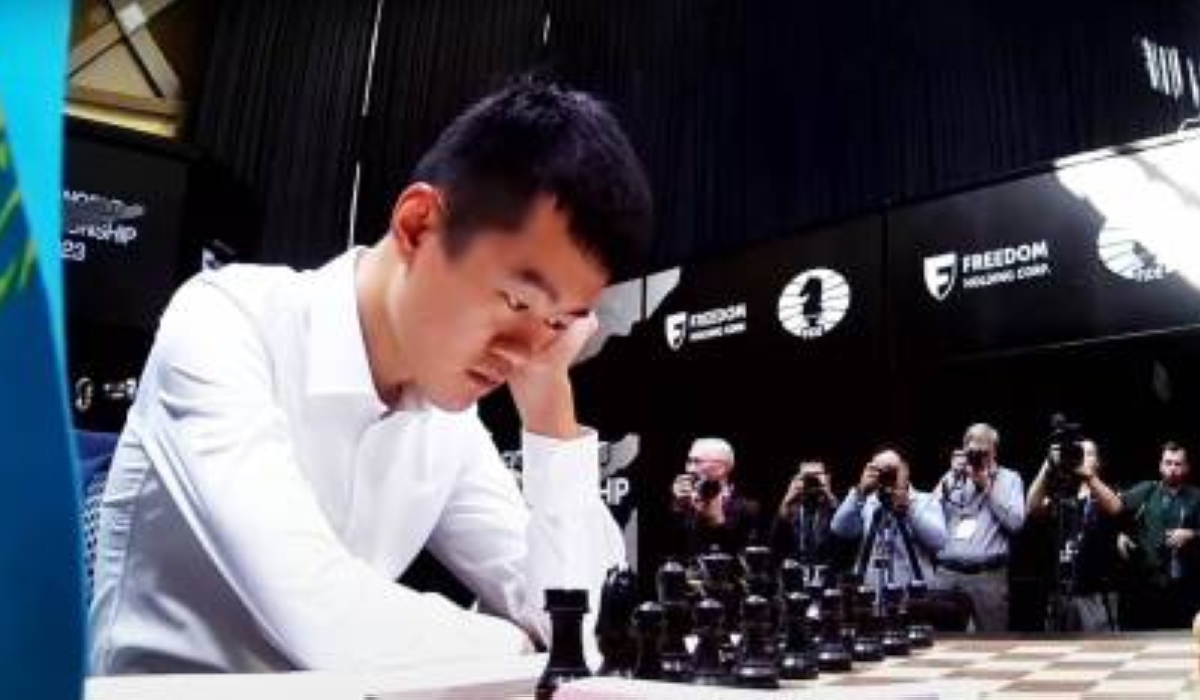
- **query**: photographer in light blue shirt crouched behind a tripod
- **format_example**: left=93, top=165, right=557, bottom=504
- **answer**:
left=833, top=449, right=947, bottom=584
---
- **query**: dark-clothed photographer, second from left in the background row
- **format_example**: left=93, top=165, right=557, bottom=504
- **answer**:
left=770, top=460, right=840, bottom=566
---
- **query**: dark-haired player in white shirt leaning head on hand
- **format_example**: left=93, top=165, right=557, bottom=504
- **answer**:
left=90, top=82, right=650, bottom=674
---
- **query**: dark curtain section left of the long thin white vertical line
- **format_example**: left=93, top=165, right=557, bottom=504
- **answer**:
left=192, top=0, right=376, bottom=268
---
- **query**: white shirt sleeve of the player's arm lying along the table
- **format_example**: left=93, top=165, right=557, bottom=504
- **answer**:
left=139, top=281, right=526, bottom=670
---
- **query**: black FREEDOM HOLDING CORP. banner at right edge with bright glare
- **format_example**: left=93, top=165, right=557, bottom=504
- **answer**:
left=888, top=132, right=1200, bottom=364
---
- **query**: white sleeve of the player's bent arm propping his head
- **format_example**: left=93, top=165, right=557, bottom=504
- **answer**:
left=430, top=423, right=625, bottom=642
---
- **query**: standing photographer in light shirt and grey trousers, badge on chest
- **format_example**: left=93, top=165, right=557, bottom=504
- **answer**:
left=935, top=423, right=1025, bottom=632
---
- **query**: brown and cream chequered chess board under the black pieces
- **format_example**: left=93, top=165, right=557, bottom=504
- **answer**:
left=369, top=632, right=1200, bottom=700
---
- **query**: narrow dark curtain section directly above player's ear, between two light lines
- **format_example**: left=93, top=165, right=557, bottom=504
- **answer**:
left=355, top=0, right=545, bottom=244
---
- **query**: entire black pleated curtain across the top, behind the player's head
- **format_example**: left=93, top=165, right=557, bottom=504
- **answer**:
left=193, top=0, right=1200, bottom=269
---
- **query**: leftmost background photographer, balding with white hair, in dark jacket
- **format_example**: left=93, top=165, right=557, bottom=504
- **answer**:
left=671, top=437, right=761, bottom=557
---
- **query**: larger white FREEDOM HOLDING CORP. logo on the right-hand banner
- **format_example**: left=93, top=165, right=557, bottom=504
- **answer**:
left=924, top=240, right=1050, bottom=301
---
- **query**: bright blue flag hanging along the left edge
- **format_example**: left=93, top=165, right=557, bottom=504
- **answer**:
left=0, top=0, right=85, bottom=700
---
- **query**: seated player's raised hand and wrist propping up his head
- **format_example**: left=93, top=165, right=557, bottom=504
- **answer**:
left=509, top=312, right=600, bottom=439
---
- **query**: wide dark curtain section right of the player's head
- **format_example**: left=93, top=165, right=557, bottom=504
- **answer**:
left=548, top=0, right=1200, bottom=269
